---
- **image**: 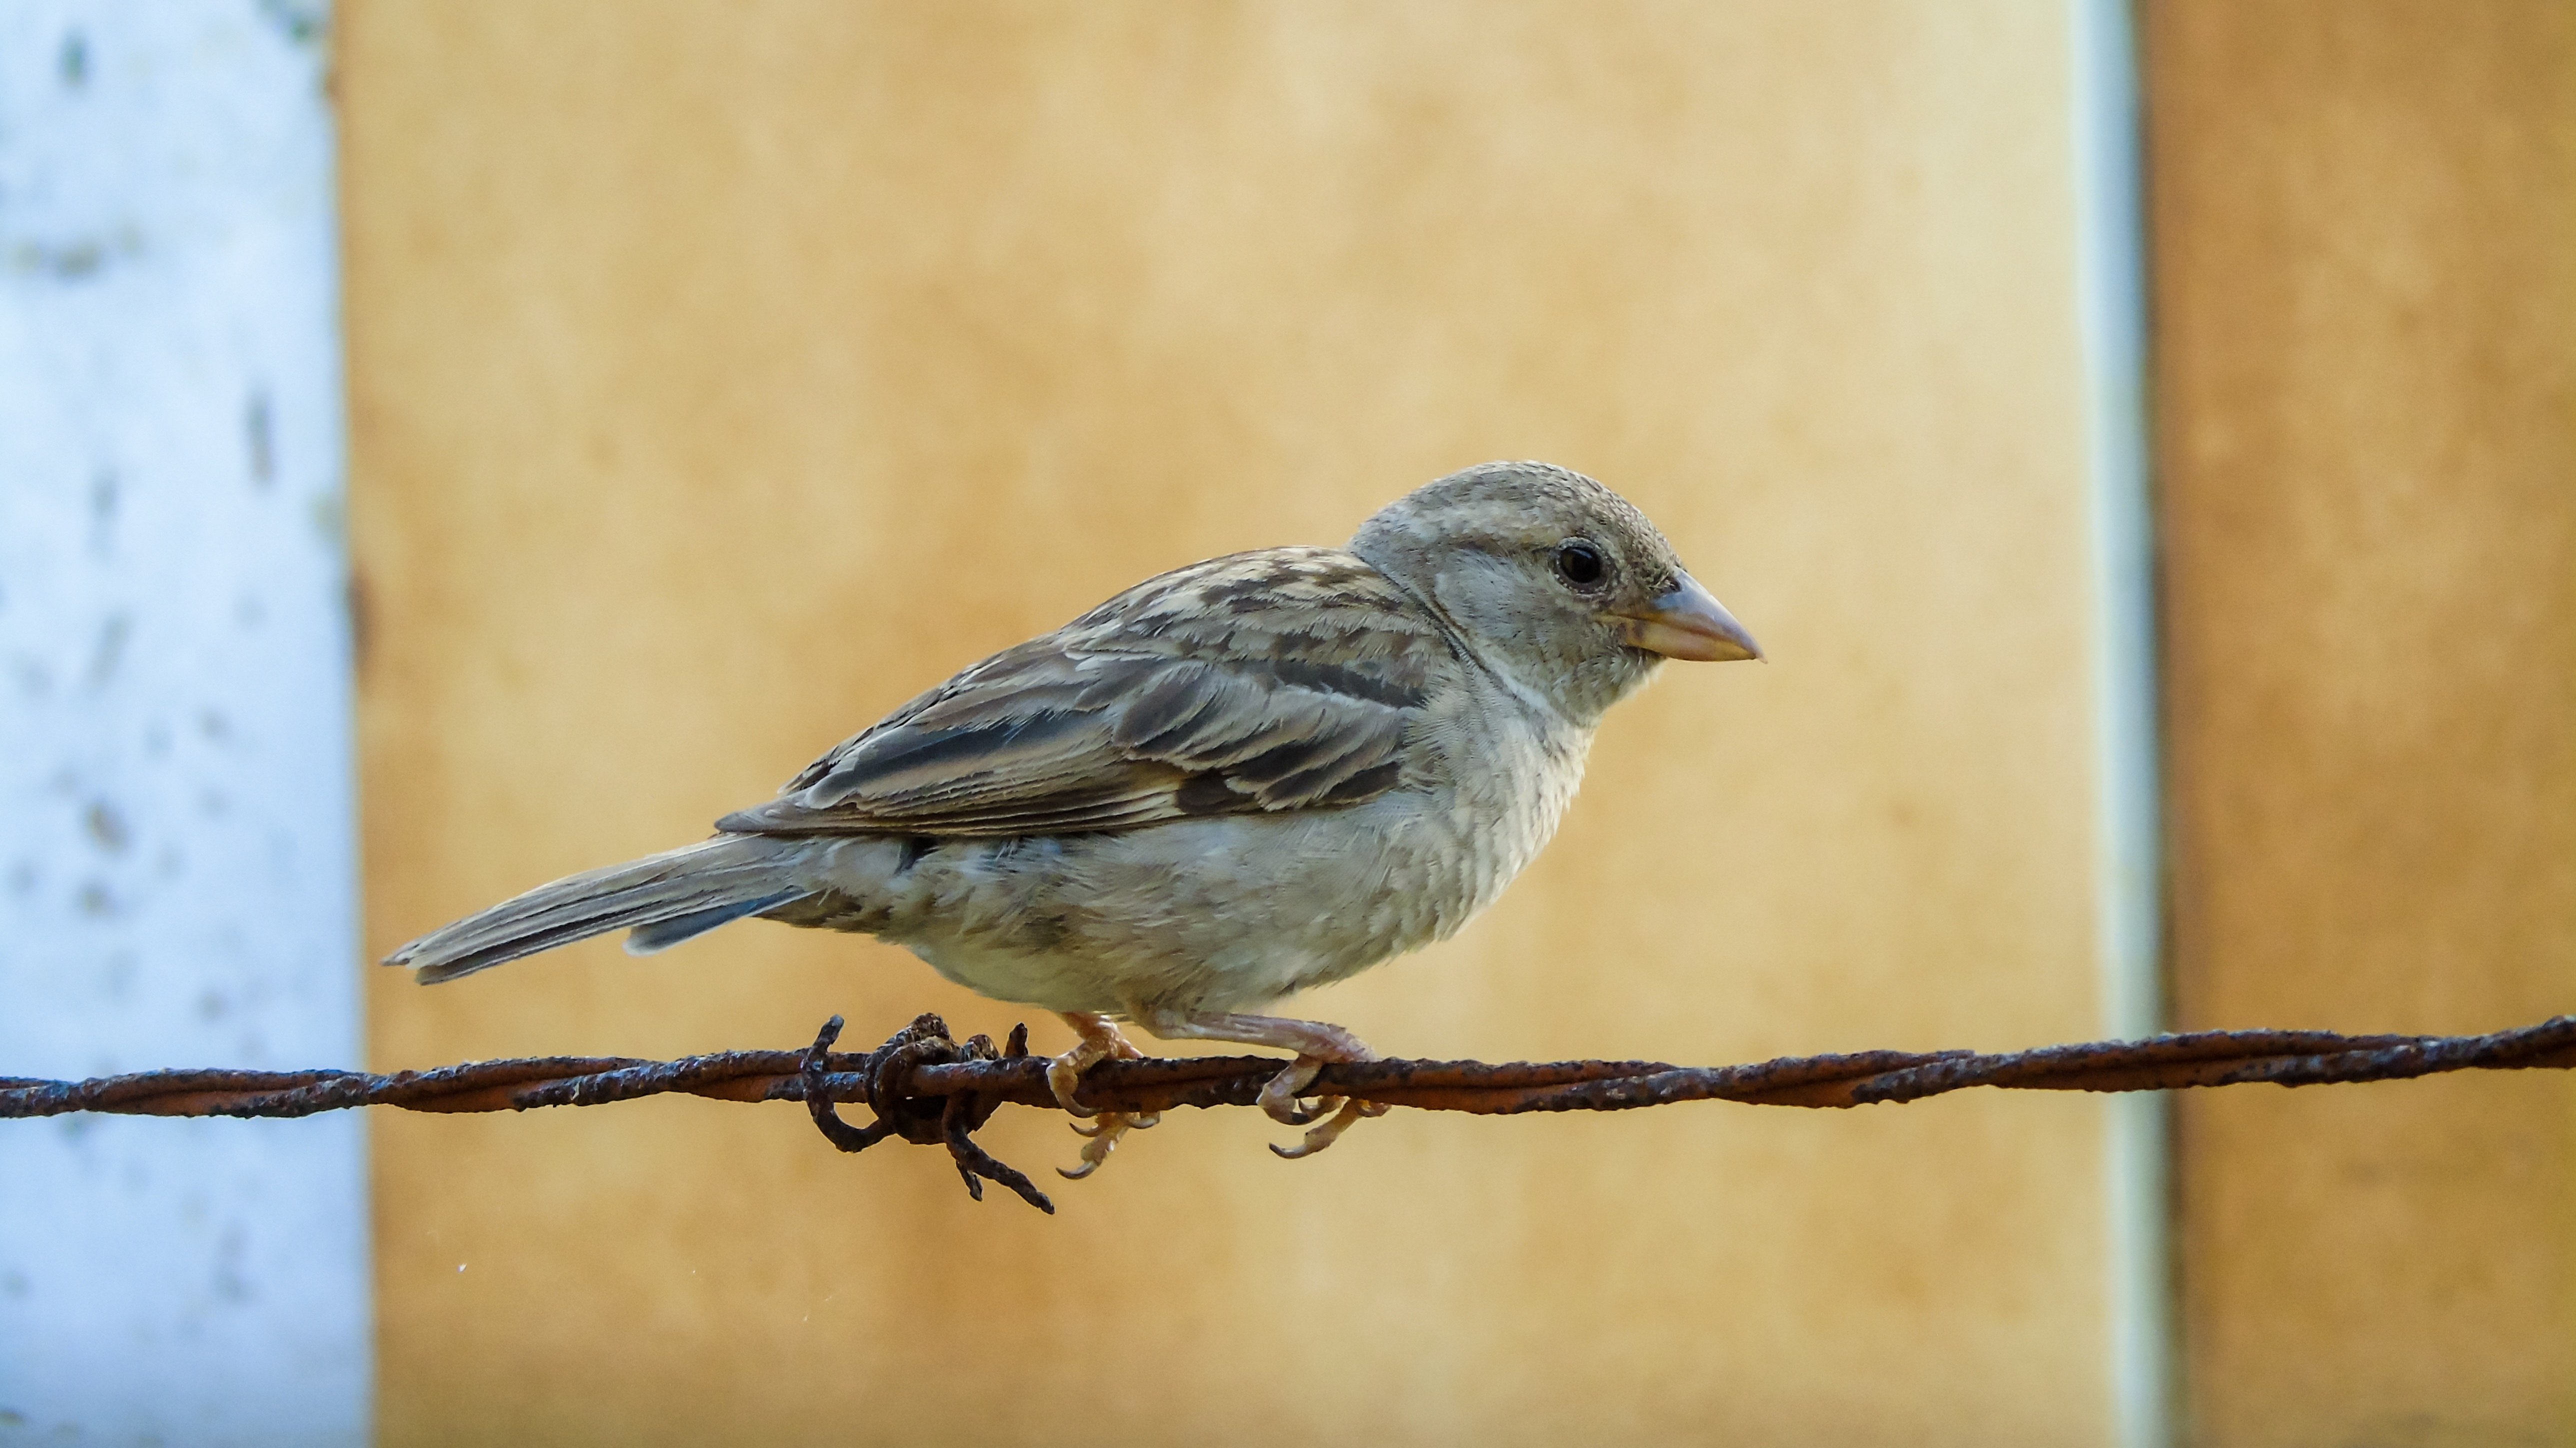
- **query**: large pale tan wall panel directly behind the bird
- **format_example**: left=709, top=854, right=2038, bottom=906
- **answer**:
left=338, top=0, right=2110, bottom=1443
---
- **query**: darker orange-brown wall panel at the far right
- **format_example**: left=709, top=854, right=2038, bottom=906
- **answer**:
left=2148, top=0, right=2576, bottom=1446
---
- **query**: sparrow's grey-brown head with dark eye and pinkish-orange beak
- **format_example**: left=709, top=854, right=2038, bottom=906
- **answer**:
left=1350, top=464, right=1762, bottom=724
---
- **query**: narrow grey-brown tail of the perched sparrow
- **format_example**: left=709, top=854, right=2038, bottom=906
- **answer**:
left=384, top=835, right=809, bottom=984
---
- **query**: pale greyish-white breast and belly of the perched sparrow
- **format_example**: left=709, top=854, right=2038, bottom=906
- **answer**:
left=806, top=714, right=1590, bottom=1015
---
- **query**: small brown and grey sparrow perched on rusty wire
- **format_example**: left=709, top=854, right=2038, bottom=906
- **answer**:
left=384, top=461, right=1762, bottom=1178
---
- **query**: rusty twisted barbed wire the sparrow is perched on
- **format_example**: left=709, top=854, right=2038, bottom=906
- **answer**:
left=0, top=1015, right=2576, bottom=1211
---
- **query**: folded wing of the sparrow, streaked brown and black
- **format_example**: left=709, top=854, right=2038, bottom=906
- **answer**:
left=718, top=549, right=1450, bottom=838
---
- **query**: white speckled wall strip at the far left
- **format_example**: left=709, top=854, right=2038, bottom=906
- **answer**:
left=0, top=0, right=371, bottom=1446
